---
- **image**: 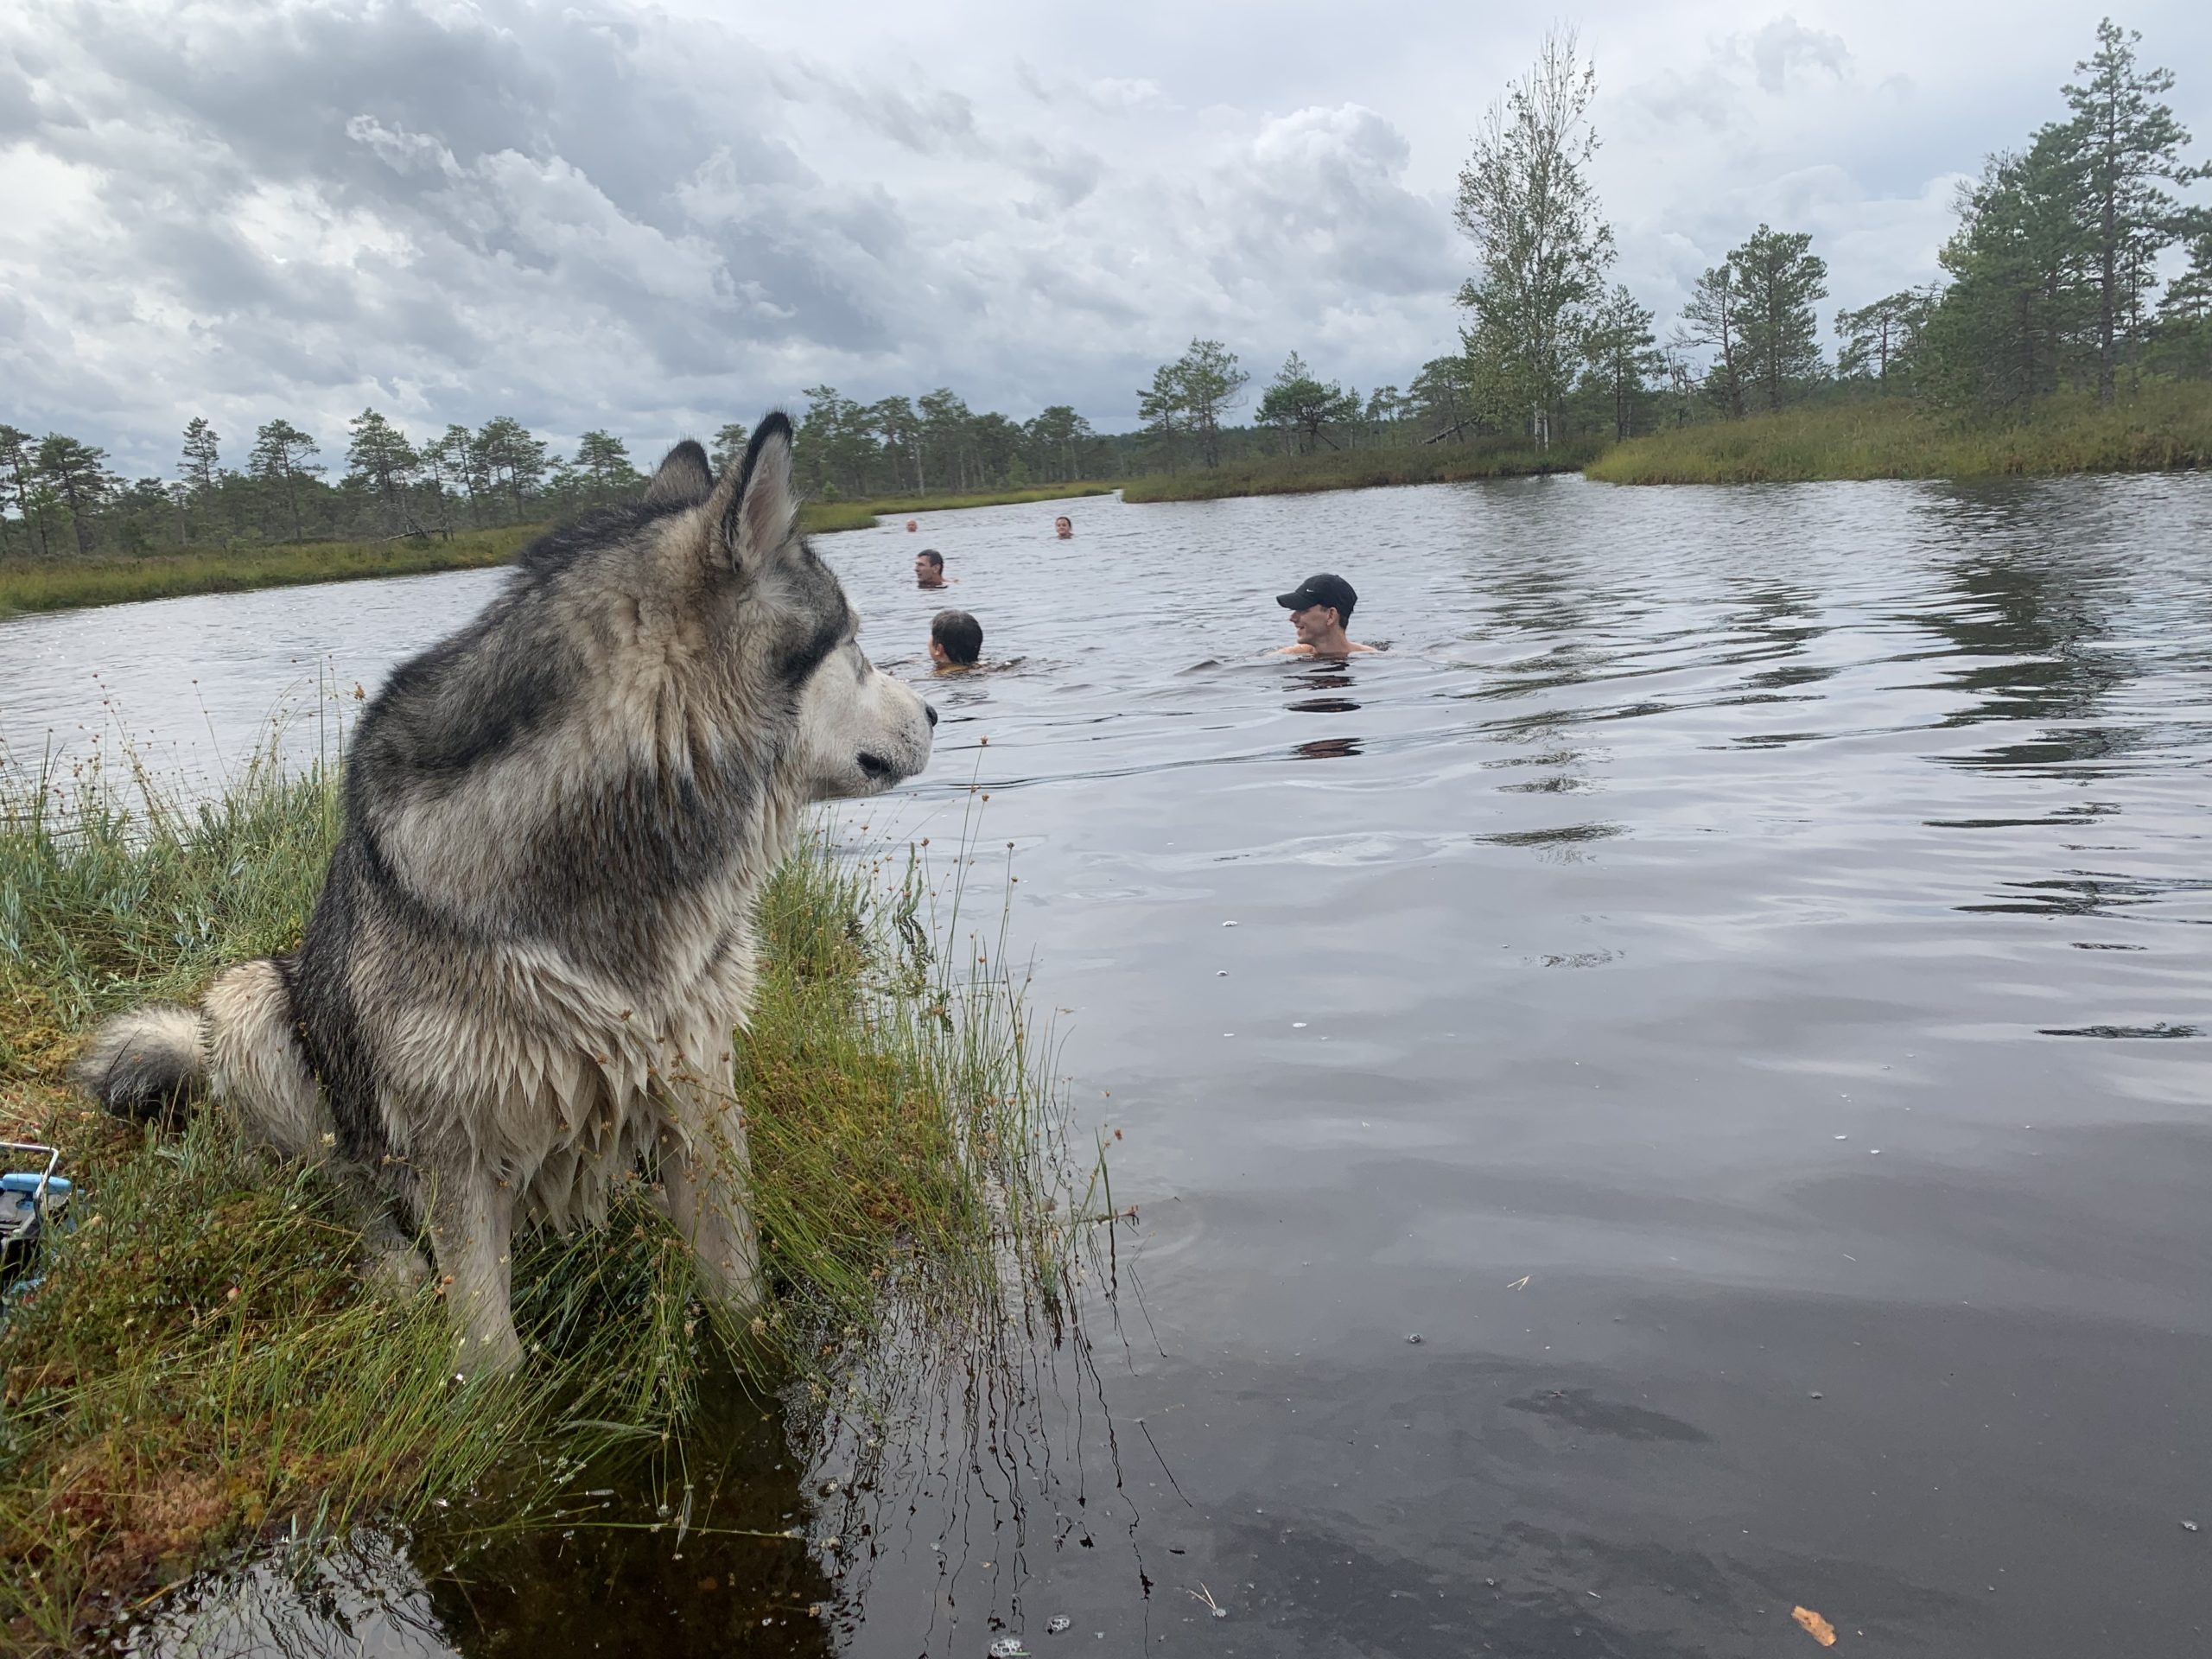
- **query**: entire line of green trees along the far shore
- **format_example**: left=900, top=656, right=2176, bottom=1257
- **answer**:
left=0, top=20, right=2212, bottom=560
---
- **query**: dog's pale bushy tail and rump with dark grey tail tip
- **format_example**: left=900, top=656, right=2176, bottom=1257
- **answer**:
left=71, top=957, right=332, bottom=1159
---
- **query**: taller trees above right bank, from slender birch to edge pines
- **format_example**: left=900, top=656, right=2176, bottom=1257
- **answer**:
left=1431, top=17, right=2212, bottom=462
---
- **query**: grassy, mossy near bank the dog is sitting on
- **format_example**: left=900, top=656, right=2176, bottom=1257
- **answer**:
left=0, top=761, right=1090, bottom=1650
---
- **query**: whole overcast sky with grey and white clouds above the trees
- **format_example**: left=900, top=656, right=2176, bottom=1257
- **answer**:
left=0, top=0, right=2212, bottom=474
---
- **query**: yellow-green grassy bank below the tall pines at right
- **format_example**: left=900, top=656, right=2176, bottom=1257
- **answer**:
left=1584, top=380, right=2212, bottom=485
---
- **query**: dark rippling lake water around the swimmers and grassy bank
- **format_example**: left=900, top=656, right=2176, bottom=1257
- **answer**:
left=0, top=478, right=2212, bottom=1659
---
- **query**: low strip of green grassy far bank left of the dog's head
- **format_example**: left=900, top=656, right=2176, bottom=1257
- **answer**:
left=0, top=524, right=544, bottom=617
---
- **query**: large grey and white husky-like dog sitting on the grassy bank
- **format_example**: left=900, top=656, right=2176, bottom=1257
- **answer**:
left=75, top=414, right=938, bottom=1370
